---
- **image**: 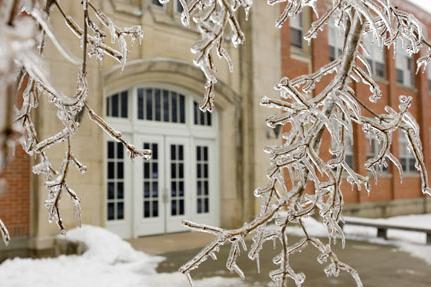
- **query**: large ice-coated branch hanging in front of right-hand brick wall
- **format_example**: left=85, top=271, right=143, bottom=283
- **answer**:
left=180, top=0, right=430, bottom=287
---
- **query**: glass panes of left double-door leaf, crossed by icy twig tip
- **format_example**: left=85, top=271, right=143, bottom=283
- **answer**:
left=142, top=143, right=160, bottom=218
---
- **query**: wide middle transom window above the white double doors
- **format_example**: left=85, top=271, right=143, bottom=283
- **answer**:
left=138, top=88, right=186, bottom=124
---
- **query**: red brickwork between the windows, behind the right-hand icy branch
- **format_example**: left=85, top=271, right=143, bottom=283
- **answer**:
left=280, top=2, right=431, bottom=203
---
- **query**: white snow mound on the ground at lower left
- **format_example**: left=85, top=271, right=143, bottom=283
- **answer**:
left=0, top=226, right=241, bottom=287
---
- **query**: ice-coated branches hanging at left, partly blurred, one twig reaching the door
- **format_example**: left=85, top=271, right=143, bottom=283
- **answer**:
left=0, top=0, right=147, bottom=245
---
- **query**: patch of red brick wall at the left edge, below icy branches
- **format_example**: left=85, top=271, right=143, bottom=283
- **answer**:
left=0, top=146, right=31, bottom=239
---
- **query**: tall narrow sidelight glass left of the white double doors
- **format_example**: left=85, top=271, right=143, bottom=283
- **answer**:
left=107, top=141, right=124, bottom=220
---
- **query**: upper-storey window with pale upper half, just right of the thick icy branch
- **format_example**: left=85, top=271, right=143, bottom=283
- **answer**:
left=364, top=34, right=386, bottom=79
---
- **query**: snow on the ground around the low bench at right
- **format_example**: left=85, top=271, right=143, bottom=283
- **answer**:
left=289, top=214, right=431, bottom=265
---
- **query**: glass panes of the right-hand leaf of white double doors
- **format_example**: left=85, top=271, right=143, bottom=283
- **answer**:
left=169, top=144, right=185, bottom=216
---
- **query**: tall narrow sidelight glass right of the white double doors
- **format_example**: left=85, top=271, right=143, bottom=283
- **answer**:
left=196, top=146, right=209, bottom=214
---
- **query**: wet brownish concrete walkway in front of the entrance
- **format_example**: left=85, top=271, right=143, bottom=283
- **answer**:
left=131, top=232, right=431, bottom=287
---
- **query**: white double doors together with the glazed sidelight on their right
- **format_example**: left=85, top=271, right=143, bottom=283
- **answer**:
left=133, top=135, right=215, bottom=236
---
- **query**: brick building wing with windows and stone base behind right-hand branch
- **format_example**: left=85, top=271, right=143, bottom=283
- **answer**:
left=281, top=1, right=431, bottom=217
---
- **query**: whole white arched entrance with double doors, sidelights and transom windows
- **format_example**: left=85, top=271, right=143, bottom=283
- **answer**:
left=105, top=85, right=219, bottom=237
